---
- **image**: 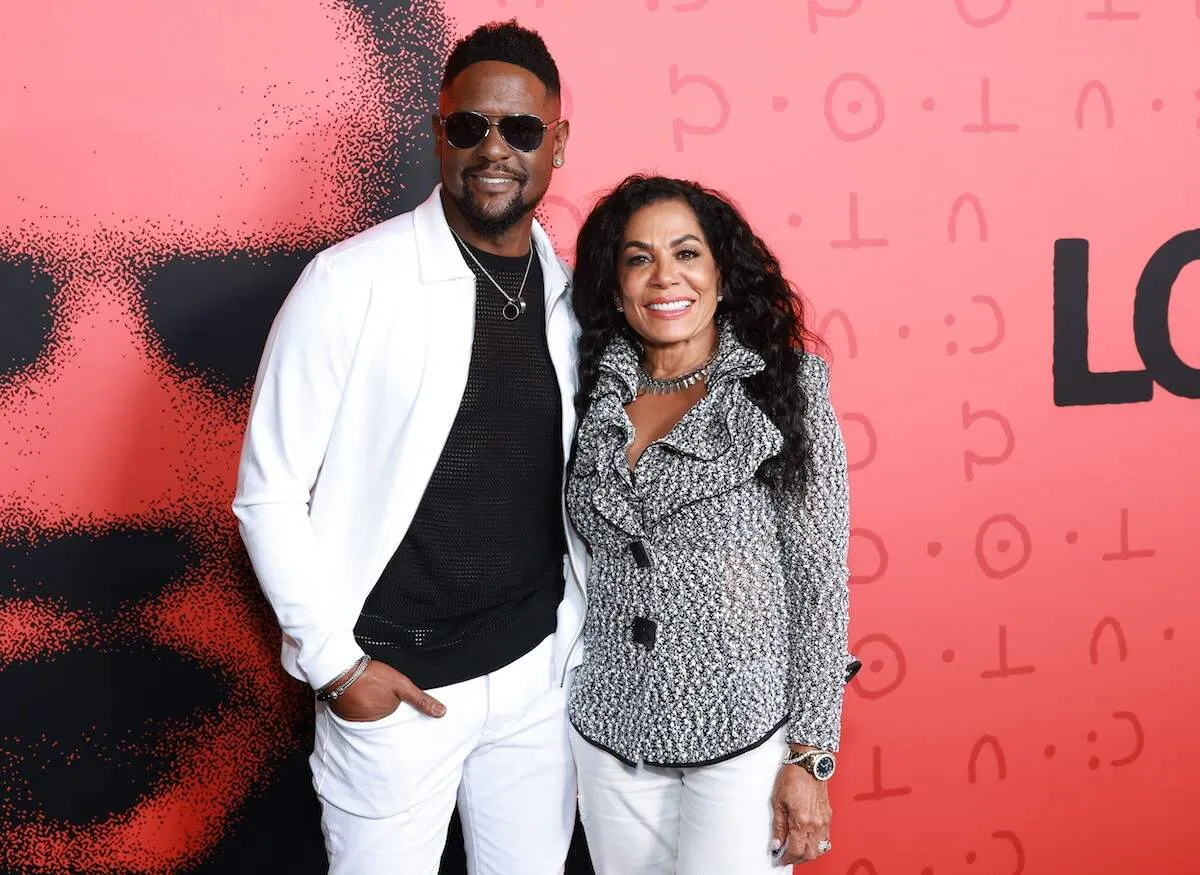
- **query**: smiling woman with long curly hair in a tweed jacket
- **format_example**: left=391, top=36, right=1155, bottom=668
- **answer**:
left=566, top=176, right=850, bottom=875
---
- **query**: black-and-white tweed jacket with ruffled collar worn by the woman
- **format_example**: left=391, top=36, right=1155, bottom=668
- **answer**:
left=566, top=326, right=850, bottom=766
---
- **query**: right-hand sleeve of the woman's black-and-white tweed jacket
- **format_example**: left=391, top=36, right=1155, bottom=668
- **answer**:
left=780, top=354, right=851, bottom=750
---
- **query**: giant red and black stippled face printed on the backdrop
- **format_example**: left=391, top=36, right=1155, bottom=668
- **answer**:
left=0, top=0, right=440, bottom=873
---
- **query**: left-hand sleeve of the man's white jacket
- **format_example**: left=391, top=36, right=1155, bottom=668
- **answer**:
left=233, top=254, right=366, bottom=688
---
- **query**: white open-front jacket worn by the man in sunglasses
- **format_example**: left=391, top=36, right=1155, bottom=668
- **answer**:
left=233, top=188, right=587, bottom=688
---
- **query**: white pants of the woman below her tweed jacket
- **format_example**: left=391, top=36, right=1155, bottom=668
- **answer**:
left=570, top=729, right=787, bottom=875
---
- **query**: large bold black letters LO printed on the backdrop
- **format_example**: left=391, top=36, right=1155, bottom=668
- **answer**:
left=1054, top=228, right=1200, bottom=407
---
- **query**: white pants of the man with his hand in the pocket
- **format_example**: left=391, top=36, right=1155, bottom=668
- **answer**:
left=310, top=636, right=575, bottom=875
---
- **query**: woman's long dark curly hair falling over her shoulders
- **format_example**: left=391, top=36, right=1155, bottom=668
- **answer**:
left=571, top=174, right=820, bottom=489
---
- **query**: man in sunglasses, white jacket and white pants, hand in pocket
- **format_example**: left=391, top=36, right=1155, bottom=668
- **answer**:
left=234, top=23, right=584, bottom=875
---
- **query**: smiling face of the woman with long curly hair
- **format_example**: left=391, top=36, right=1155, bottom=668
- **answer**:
left=617, top=200, right=721, bottom=352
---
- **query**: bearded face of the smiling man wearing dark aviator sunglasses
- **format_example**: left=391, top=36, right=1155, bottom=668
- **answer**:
left=433, top=61, right=569, bottom=239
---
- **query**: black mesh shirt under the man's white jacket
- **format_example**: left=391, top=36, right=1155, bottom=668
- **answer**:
left=354, top=237, right=566, bottom=689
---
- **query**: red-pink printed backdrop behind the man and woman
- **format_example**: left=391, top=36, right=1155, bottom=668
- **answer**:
left=0, top=0, right=1200, bottom=875
